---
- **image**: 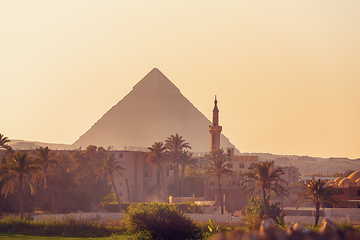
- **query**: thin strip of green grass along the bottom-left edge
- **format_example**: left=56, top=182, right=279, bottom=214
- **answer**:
left=0, top=233, right=131, bottom=240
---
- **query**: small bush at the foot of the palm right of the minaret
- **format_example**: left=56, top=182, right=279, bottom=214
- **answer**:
left=243, top=196, right=284, bottom=230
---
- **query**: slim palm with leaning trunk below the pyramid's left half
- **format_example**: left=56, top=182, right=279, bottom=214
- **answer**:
left=97, top=155, right=124, bottom=212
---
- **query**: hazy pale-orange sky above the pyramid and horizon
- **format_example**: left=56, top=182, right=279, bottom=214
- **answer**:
left=0, top=0, right=360, bottom=158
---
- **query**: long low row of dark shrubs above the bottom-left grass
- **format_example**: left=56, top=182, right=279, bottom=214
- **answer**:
left=0, top=217, right=123, bottom=237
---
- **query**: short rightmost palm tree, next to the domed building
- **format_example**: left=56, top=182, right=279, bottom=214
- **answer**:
left=295, top=177, right=339, bottom=226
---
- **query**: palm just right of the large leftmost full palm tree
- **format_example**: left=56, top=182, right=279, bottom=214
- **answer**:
left=32, top=147, right=58, bottom=212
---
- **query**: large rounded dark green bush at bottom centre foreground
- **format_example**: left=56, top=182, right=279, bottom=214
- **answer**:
left=125, top=203, right=202, bottom=240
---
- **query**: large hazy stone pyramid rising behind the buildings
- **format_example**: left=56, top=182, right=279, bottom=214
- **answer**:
left=72, top=68, right=239, bottom=153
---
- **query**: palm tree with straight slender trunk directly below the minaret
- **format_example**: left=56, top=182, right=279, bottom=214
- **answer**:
left=205, top=149, right=232, bottom=214
